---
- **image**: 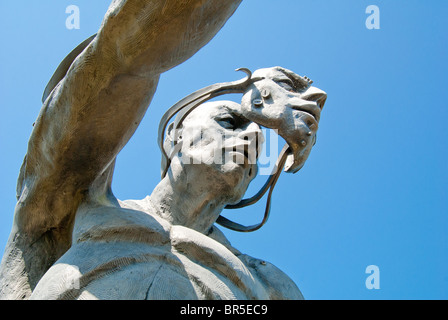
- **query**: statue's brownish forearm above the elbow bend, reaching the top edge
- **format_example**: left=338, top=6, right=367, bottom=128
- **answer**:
left=99, top=0, right=242, bottom=74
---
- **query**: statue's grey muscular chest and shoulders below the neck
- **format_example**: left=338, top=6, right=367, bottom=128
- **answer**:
left=31, top=202, right=303, bottom=300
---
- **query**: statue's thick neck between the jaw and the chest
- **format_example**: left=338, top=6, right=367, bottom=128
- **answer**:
left=150, top=177, right=225, bottom=234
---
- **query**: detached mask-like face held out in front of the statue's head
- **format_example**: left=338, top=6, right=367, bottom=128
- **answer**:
left=241, top=67, right=327, bottom=172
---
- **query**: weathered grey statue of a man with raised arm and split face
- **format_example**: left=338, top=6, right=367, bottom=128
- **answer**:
left=0, top=0, right=326, bottom=300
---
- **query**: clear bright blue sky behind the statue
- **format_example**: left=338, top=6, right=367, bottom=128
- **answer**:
left=0, top=0, right=448, bottom=299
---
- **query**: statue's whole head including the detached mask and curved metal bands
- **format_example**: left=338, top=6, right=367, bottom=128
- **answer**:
left=159, top=67, right=327, bottom=232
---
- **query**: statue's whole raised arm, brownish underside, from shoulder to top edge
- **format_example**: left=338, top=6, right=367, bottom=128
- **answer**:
left=0, top=0, right=241, bottom=299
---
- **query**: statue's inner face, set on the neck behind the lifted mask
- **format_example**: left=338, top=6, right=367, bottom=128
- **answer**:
left=170, top=101, right=264, bottom=203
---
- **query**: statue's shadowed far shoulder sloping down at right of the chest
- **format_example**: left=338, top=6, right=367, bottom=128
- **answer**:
left=209, top=227, right=304, bottom=300
